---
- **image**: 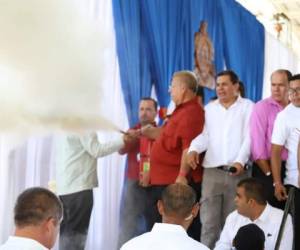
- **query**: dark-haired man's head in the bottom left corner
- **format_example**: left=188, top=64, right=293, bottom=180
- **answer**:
left=14, top=187, right=63, bottom=249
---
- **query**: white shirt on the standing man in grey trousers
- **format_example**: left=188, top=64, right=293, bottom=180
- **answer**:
left=189, top=97, right=253, bottom=168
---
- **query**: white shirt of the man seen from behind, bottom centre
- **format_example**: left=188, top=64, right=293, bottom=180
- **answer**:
left=121, top=223, right=209, bottom=250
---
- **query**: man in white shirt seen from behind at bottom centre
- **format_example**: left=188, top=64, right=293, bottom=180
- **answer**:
left=121, top=183, right=208, bottom=250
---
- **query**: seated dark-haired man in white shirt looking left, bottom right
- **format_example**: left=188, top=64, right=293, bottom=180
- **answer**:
left=215, top=178, right=293, bottom=250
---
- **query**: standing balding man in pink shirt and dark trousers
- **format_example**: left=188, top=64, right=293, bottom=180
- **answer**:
left=250, top=69, right=292, bottom=209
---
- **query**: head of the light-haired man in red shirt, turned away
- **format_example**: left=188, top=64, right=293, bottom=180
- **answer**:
left=169, top=70, right=197, bottom=106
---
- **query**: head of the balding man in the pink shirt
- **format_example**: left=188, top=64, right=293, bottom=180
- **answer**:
left=271, top=69, right=292, bottom=104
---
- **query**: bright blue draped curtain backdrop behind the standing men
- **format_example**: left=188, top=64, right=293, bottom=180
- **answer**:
left=113, top=0, right=264, bottom=124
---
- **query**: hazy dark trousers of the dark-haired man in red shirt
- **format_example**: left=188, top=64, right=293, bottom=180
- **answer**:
left=118, top=179, right=148, bottom=249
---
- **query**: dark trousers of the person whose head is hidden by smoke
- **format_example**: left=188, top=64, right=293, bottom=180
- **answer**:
left=59, top=190, right=93, bottom=250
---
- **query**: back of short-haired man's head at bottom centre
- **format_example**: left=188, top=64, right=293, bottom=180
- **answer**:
left=157, top=183, right=199, bottom=229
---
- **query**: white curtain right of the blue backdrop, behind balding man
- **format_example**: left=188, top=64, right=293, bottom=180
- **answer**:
left=263, top=32, right=300, bottom=98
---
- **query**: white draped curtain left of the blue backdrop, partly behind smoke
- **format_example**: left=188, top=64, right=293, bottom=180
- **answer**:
left=0, top=0, right=128, bottom=250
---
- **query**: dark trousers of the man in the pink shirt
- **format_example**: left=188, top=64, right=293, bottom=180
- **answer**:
left=252, top=162, right=285, bottom=210
